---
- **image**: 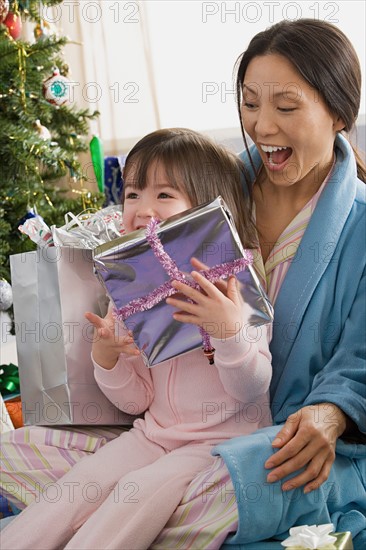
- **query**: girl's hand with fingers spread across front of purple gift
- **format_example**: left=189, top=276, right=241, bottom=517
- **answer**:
left=166, top=271, right=243, bottom=339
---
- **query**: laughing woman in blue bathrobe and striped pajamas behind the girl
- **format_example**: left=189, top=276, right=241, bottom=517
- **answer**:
left=0, top=20, right=366, bottom=549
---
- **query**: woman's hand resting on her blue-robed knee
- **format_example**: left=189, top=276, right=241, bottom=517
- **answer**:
left=265, top=403, right=347, bottom=493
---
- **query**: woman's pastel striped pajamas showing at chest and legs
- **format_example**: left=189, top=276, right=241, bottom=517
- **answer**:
left=0, top=171, right=329, bottom=550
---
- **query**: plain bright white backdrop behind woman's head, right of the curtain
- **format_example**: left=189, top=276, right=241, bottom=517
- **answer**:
left=145, top=1, right=366, bottom=129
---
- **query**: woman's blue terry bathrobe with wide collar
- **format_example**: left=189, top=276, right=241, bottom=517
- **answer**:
left=213, top=135, right=366, bottom=550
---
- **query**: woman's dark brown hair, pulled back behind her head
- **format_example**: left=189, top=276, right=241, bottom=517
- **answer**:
left=235, top=19, right=366, bottom=182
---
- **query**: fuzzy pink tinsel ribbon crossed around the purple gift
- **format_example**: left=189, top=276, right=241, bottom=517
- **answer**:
left=114, top=218, right=253, bottom=362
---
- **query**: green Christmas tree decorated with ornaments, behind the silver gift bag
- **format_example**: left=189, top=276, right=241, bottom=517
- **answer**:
left=0, top=0, right=104, bottom=294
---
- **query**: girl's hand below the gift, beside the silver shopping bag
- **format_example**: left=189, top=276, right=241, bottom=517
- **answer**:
left=85, top=310, right=140, bottom=370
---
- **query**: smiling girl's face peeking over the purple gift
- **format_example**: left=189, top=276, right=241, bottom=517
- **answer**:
left=123, top=162, right=192, bottom=233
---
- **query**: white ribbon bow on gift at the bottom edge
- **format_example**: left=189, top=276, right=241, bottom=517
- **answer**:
left=281, top=523, right=337, bottom=549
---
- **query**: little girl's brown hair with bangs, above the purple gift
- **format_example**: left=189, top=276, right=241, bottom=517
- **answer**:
left=122, top=128, right=257, bottom=248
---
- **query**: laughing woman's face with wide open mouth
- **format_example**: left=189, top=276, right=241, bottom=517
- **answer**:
left=241, top=54, right=344, bottom=189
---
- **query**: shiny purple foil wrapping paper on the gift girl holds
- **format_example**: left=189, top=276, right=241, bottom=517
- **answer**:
left=93, top=197, right=273, bottom=367
